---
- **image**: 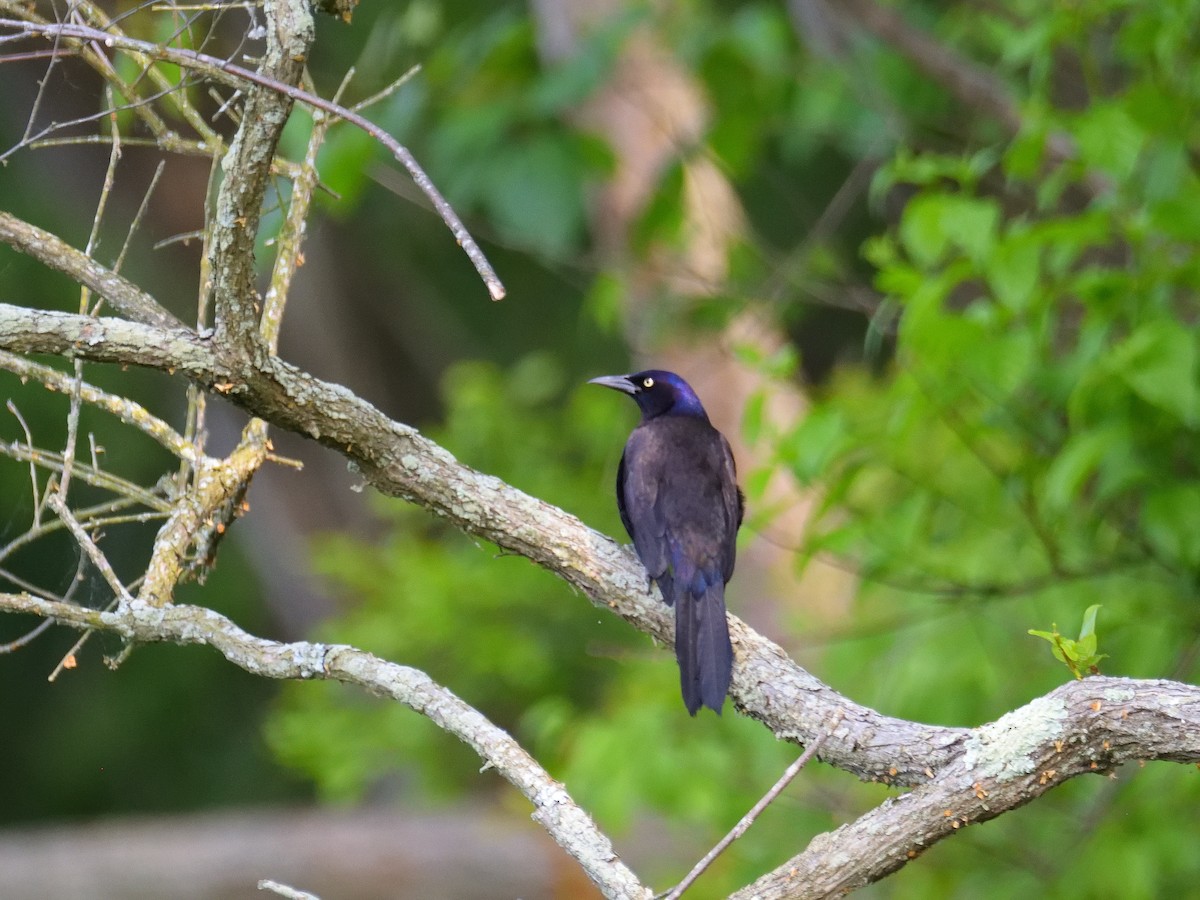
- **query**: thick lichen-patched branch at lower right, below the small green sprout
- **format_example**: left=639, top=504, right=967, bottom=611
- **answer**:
left=733, top=677, right=1200, bottom=900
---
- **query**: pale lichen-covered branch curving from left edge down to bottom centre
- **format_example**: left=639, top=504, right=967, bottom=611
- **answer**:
left=0, top=594, right=650, bottom=900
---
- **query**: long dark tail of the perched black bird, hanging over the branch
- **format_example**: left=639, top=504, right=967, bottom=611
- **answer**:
left=672, top=569, right=733, bottom=715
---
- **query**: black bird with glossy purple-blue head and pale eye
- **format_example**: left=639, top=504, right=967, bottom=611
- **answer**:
left=589, top=368, right=744, bottom=715
